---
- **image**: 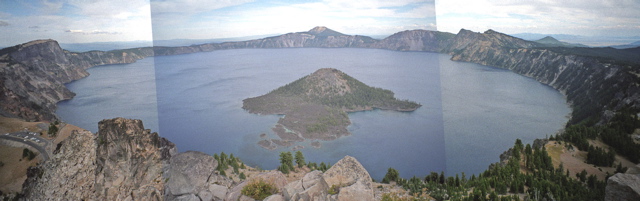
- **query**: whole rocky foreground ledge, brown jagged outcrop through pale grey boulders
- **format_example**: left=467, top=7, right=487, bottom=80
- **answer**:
left=22, top=118, right=375, bottom=201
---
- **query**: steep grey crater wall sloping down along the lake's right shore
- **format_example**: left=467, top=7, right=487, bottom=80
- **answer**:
left=443, top=30, right=640, bottom=123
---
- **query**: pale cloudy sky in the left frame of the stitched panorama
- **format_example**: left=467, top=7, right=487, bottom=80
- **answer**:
left=0, top=0, right=153, bottom=46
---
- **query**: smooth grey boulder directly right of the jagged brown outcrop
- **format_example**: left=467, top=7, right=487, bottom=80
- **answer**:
left=165, top=151, right=219, bottom=200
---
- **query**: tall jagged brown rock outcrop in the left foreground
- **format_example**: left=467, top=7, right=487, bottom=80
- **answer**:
left=23, top=118, right=176, bottom=200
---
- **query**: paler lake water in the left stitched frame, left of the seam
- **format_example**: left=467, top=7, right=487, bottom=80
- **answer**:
left=56, top=59, right=159, bottom=133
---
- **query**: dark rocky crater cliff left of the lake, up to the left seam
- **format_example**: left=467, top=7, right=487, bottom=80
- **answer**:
left=0, top=40, right=153, bottom=121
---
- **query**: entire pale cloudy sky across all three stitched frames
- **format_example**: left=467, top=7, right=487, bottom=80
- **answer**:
left=0, top=0, right=640, bottom=46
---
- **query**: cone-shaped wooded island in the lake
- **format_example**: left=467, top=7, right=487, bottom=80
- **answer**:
left=242, top=68, right=421, bottom=150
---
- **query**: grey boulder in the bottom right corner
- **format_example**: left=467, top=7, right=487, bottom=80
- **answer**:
left=604, top=173, right=640, bottom=201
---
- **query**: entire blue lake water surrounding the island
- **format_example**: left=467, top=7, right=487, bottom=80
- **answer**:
left=57, top=48, right=569, bottom=179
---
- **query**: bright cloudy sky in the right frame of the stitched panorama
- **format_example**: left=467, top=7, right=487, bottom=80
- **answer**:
left=436, top=0, right=640, bottom=35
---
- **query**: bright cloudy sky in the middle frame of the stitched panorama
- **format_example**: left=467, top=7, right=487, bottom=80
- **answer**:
left=151, top=0, right=435, bottom=40
